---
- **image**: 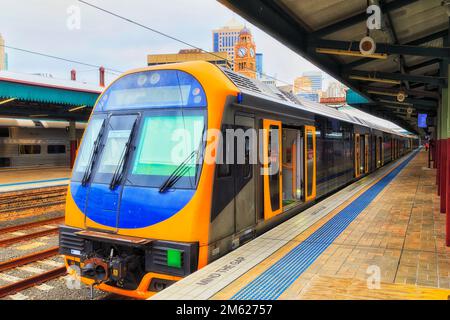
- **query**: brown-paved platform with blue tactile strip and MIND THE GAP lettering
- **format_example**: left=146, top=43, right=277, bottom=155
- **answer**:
left=151, top=151, right=450, bottom=300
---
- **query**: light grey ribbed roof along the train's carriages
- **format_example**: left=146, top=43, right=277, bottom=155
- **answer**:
left=220, top=67, right=415, bottom=138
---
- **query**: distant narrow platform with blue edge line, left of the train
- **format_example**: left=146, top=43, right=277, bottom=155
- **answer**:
left=0, top=167, right=71, bottom=193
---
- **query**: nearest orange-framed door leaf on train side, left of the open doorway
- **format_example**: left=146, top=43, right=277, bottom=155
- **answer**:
left=263, top=119, right=283, bottom=220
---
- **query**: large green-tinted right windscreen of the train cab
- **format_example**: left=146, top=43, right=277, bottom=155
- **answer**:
left=129, top=111, right=205, bottom=189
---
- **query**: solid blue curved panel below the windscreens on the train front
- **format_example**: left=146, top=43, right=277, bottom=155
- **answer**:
left=70, top=182, right=195, bottom=229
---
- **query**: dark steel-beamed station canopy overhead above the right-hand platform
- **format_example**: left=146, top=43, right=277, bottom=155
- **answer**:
left=219, top=0, right=450, bottom=133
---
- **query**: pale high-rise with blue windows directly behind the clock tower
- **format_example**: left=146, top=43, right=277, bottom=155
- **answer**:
left=213, top=18, right=244, bottom=67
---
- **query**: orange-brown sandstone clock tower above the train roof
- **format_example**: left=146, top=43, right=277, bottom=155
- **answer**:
left=234, top=27, right=256, bottom=79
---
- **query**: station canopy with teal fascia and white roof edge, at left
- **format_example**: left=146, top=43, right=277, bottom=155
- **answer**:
left=0, top=71, right=103, bottom=121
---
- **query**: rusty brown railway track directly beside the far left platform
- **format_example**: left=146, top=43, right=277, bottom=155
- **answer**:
left=0, top=186, right=67, bottom=213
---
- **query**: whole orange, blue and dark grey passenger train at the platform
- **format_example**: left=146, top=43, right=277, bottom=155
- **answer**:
left=60, top=61, right=418, bottom=299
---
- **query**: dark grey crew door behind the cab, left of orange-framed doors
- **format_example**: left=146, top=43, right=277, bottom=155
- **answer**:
left=234, top=115, right=257, bottom=233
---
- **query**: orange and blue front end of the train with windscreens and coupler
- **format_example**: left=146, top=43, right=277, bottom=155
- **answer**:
left=60, top=63, right=237, bottom=298
